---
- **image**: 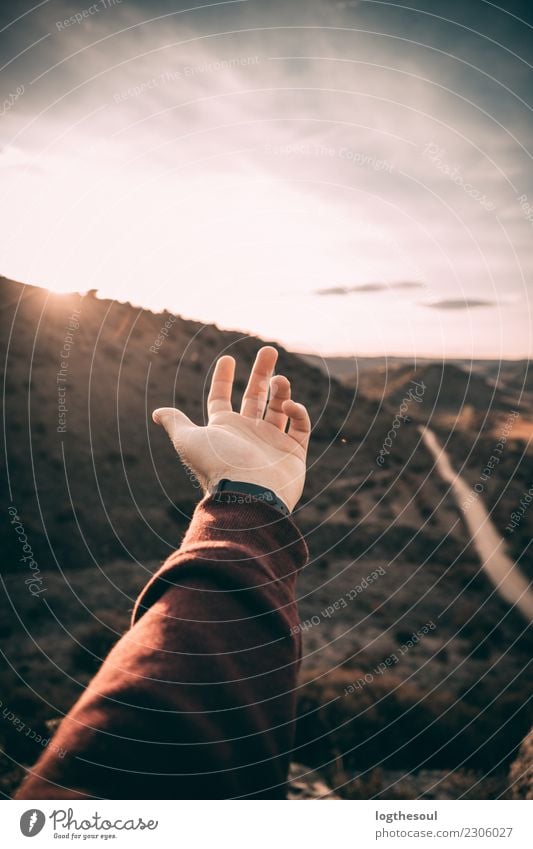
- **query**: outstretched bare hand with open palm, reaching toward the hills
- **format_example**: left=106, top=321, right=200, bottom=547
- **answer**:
left=153, top=346, right=311, bottom=510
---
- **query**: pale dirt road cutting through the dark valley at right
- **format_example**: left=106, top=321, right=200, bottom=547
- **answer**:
left=419, top=427, right=533, bottom=622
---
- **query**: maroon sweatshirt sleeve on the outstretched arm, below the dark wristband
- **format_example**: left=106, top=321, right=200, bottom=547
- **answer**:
left=16, top=492, right=307, bottom=799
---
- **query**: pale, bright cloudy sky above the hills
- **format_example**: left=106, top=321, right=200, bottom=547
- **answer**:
left=0, top=0, right=533, bottom=358
